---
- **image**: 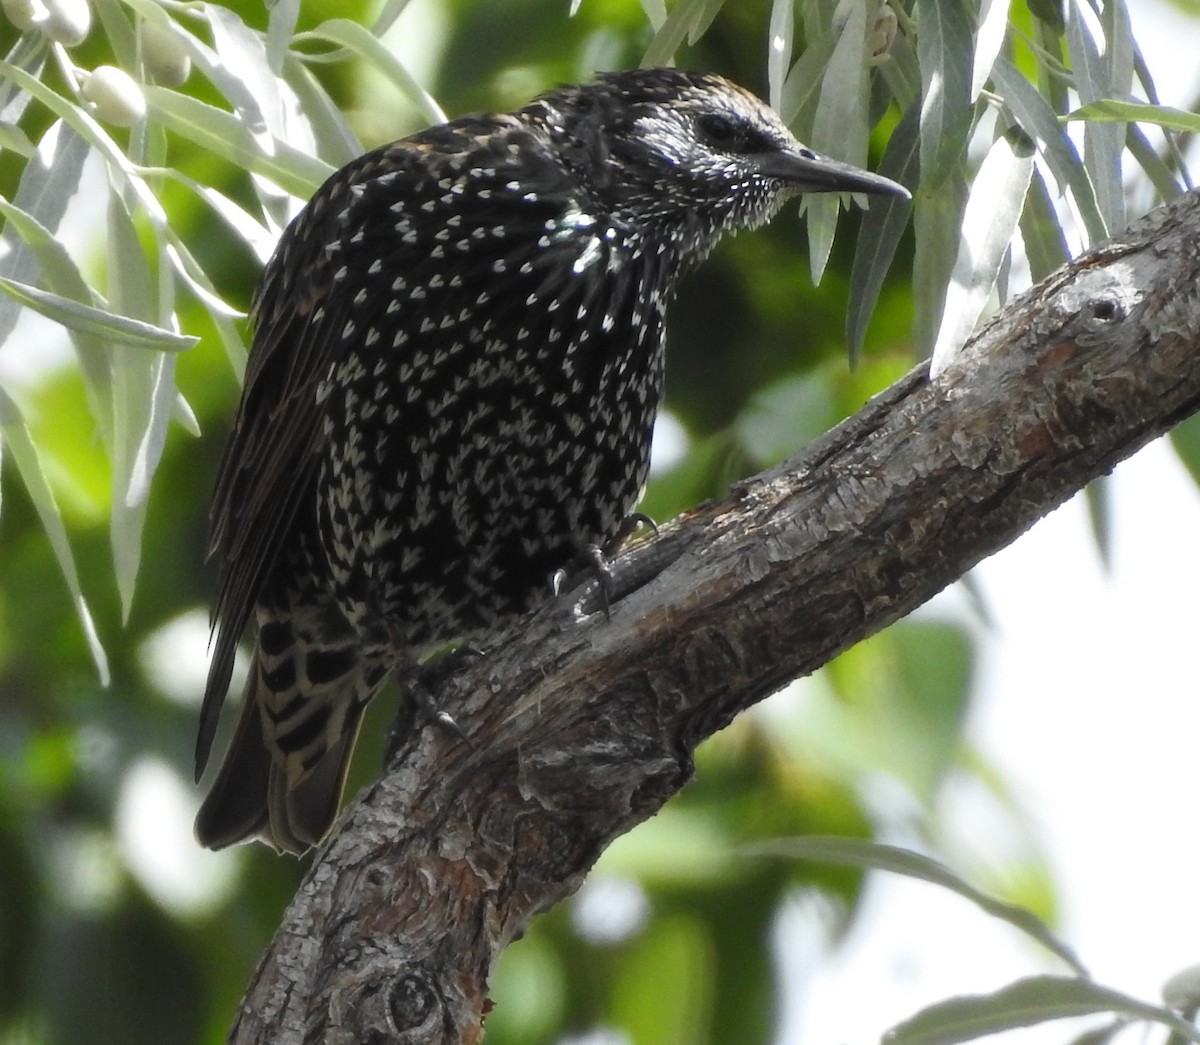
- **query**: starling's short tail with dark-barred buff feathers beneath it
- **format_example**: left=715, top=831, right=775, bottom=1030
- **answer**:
left=196, top=619, right=386, bottom=855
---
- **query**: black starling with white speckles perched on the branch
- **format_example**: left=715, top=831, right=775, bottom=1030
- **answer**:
left=196, top=68, right=908, bottom=854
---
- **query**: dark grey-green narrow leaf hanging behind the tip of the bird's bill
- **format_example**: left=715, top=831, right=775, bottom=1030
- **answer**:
left=846, top=95, right=920, bottom=366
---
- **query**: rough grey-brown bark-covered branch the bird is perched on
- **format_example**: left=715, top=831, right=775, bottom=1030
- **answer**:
left=230, top=193, right=1200, bottom=1045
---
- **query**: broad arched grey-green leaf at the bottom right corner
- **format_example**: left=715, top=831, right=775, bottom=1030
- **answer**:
left=883, top=977, right=1200, bottom=1045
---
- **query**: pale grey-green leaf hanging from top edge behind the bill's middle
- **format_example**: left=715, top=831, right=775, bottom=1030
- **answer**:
left=804, top=4, right=871, bottom=283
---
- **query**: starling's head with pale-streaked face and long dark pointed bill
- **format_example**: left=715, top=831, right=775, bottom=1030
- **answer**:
left=535, top=68, right=908, bottom=250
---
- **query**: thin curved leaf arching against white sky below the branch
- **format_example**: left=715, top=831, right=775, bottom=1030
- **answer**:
left=743, top=835, right=1087, bottom=977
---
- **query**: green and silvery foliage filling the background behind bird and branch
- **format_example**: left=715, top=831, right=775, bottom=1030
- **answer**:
left=0, top=0, right=1200, bottom=1045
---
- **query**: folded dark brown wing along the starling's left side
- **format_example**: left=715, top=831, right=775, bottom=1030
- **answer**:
left=196, top=134, right=451, bottom=777
